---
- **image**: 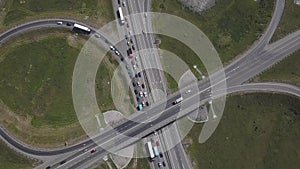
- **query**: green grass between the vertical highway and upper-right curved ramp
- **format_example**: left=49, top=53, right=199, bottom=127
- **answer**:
left=152, top=0, right=274, bottom=63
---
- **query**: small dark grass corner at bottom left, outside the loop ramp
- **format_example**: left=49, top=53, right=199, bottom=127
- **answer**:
left=0, top=140, right=38, bottom=169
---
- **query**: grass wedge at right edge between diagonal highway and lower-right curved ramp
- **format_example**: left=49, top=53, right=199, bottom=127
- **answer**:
left=251, top=50, right=300, bottom=86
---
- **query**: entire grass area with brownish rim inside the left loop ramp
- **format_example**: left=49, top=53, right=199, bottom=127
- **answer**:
left=0, top=29, right=119, bottom=147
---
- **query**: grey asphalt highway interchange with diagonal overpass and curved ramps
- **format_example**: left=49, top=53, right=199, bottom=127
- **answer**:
left=0, top=0, right=300, bottom=169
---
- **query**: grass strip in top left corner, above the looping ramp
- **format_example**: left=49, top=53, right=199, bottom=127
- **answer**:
left=0, top=0, right=114, bottom=30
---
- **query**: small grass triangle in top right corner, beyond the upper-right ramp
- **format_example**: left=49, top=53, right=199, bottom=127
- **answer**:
left=271, top=0, right=300, bottom=41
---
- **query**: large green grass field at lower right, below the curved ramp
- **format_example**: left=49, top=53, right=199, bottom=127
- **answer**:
left=184, top=94, right=300, bottom=169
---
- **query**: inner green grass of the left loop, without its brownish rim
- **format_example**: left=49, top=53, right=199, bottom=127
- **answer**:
left=0, top=38, right=79, bottom=127
